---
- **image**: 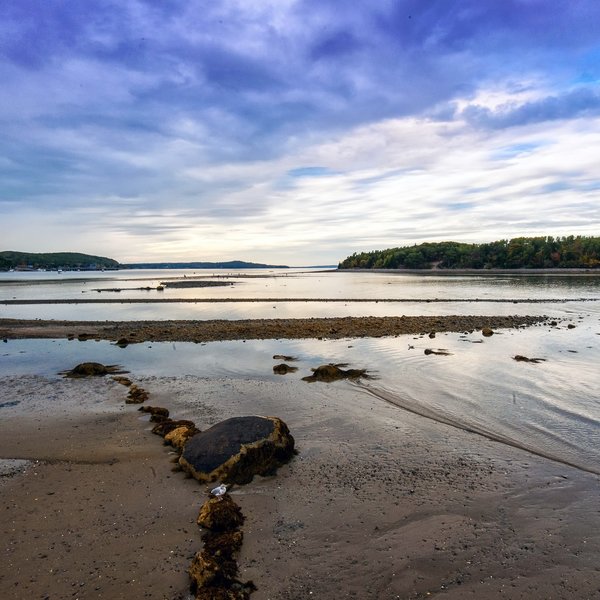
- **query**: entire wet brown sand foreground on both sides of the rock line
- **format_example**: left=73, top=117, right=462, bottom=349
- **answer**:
left=0, top=316, right=600, bottom=600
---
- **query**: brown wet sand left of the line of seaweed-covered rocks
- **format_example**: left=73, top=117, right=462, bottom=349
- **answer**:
left=0, top=377, right=202, bottom=600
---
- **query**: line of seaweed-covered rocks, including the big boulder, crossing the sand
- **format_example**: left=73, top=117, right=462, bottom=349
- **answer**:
left=62, top=362, right=295, bottom=600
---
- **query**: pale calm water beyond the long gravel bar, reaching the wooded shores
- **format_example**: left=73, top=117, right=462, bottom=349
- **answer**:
left=0, top=269, right=600, bottom=320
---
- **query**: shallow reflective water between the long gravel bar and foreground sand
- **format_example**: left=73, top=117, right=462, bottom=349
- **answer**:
left=0, top=315, right=600, bottom=472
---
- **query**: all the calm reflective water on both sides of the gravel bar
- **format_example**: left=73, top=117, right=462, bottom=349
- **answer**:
left=0, top=271, right=600, bottom=473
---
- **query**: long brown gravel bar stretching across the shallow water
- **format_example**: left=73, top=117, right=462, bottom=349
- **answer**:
left=0, top=315, right=548, bottom=342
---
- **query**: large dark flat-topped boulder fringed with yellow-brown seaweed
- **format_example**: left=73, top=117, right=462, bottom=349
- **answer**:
left=179, top=416, right=294, bottom=483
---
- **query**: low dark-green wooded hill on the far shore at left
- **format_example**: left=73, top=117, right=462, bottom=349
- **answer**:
left=0, top=250, right=119, bottom=271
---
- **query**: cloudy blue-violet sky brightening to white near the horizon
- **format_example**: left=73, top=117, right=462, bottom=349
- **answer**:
left=0, top=0, right=600, bottom=265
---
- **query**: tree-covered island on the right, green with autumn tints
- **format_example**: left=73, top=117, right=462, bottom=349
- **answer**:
left=338, top=235, right=600, bottom=269
